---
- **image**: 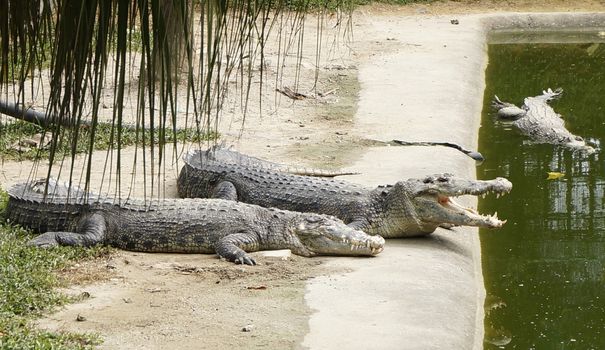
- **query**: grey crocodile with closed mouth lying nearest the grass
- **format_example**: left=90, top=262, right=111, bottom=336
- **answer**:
left=7, top=180, right=384, bottom=265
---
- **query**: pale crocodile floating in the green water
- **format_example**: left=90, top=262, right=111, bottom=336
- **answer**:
left=492, top=88, right=595, bottom=155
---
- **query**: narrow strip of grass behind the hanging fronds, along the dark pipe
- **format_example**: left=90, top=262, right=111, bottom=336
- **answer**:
left=0, top=120, right=218, bottom=160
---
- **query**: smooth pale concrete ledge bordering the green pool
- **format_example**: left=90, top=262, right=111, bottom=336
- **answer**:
left=303, top=13, right=605, bottom=349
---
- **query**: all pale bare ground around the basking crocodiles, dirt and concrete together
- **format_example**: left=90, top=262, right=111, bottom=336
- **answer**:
left=0, top=1, right=605, bottom=349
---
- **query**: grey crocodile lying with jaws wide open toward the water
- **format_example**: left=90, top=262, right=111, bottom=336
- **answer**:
left=177, top=147, right=512, bottom=237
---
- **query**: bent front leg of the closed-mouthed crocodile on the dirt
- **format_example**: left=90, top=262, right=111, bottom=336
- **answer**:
left=214, top=232, right=259, bottom=265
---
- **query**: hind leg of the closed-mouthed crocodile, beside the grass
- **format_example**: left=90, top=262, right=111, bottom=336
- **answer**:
left=28, top=214, right=107, bottom=248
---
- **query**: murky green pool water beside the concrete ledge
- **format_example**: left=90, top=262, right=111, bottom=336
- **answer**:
left=477, top=43, right=605, bottom=350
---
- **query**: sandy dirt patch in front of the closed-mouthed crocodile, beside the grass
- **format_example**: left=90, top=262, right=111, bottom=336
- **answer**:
left=47, top=252, right=340, bottom=349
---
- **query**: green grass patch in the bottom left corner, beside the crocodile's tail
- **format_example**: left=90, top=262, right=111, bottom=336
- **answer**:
left=0, top=190, right=111, bottom=349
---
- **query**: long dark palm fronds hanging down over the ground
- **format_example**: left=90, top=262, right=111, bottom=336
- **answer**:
left=0, top=0, right=350, bottom=196
